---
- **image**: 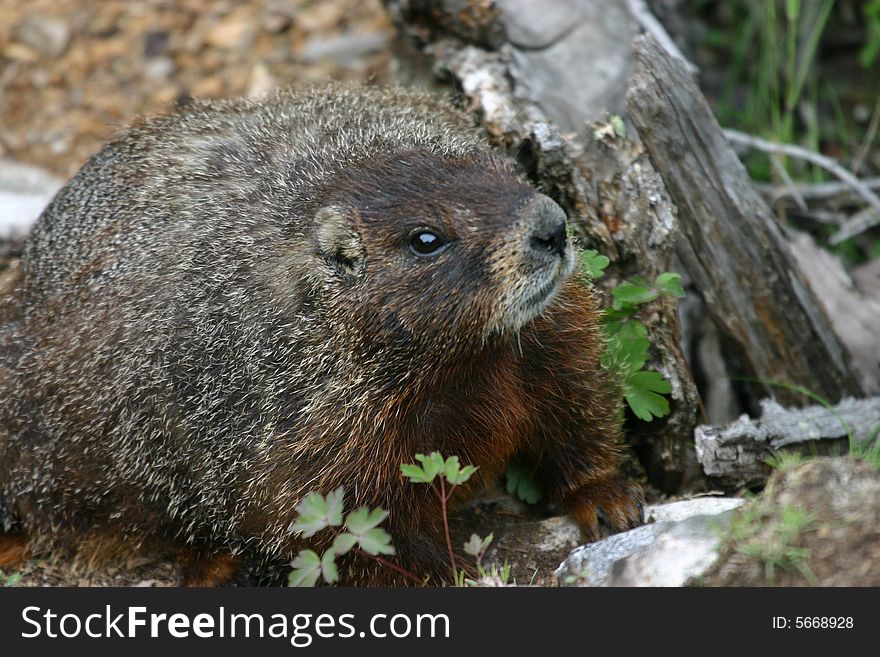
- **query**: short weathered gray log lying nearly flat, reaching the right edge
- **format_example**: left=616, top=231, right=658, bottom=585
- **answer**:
left=694, top=397, right=880, bottom=490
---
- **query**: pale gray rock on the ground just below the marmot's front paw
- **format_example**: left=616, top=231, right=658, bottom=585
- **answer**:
left=556, top=498, right=743, bottom=586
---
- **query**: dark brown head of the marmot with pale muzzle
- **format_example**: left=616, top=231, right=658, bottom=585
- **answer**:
left=317, top=153, right=573, bottom=349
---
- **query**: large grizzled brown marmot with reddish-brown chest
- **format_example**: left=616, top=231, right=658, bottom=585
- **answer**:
left=0, top=86, right=641, bottom=584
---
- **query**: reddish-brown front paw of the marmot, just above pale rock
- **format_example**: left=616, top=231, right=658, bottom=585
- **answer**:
left=566, top=477, right=645, bottom=541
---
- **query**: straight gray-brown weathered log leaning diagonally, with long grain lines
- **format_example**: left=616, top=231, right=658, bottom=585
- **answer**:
left=627, top=36, right=863, bottom=402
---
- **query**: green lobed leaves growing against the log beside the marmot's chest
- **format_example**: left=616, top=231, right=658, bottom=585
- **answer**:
left=581, top=250, right=684, bottom=422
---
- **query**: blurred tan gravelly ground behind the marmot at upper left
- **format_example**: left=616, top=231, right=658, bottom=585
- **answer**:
left=0, top=0, right=392, bottom=177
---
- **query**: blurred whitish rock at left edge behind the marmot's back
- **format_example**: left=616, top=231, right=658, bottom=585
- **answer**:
left=0, top=159, right=63, bottom=240
